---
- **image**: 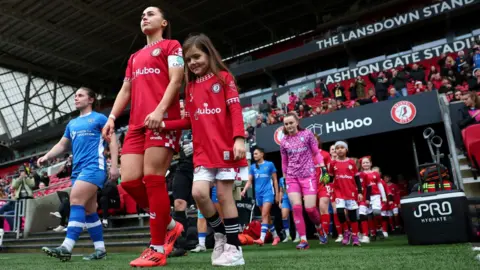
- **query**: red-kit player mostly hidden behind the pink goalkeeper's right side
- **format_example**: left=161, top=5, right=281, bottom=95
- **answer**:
left=315, top=135, right=332, bottom=238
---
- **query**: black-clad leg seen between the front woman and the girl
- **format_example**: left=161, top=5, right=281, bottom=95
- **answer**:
left=171, top=170, right=193, bottom=257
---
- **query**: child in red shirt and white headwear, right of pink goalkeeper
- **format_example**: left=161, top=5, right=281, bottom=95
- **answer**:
left=329, top=141, right=363, bottom=246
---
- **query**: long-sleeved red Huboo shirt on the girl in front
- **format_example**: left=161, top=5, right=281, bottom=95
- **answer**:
left=165, top=71, right=248, bottom=168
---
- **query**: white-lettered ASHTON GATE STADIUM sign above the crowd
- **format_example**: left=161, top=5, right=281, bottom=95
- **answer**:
left=318, top=36, right=480, bottom=84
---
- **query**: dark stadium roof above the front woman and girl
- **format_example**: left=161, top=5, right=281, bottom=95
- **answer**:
left=0, top=0, right=408, bottom=89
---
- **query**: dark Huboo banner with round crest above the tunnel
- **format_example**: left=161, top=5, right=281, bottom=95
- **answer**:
left=256, top=91, right=442, bottom=153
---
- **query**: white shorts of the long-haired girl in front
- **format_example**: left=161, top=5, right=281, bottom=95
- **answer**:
left=193, top=166, right=248, bottom=182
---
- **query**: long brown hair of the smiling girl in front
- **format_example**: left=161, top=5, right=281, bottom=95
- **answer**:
left=183, top=33, right=236, bottom=84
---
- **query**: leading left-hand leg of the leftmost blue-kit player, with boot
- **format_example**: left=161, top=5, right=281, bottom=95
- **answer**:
left=42, top=180, right=98, bottom=261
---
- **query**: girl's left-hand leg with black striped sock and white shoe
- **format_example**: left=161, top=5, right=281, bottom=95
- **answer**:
left=192, top=170, right=227, bottom=263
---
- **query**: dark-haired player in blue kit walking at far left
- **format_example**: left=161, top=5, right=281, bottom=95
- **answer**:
left=38, top=87, right=119, bottom=261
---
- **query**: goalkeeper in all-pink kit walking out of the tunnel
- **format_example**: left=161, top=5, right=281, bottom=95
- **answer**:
left=280, top=113, right=329, bottom=249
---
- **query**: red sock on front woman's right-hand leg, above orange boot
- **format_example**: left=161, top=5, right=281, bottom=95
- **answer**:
left=144, top=175, right=171, bottom=245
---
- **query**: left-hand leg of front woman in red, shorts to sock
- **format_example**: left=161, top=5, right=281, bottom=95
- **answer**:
left=120, top=128, right=148, bottom=211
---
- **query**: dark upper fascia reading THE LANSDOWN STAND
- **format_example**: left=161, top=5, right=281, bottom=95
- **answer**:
left=230, top=0, right=480, bottom=76
